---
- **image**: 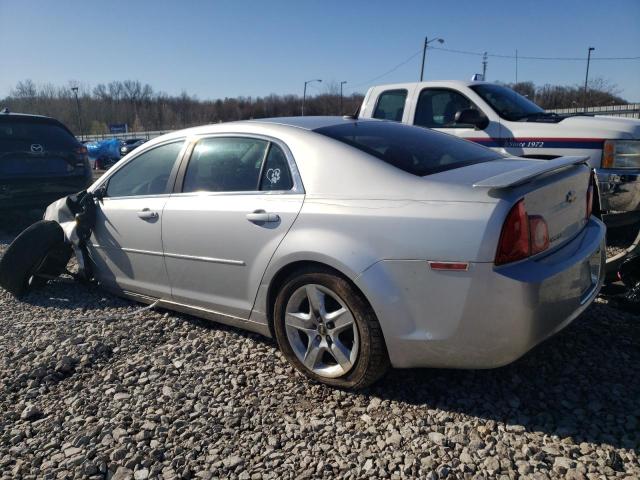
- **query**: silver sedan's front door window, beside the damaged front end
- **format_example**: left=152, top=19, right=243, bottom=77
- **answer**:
left=107, top=141, right=184, bottom=197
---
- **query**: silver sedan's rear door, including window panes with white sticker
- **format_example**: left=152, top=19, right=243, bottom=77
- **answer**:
left=162, top=136, right=304, bottom=318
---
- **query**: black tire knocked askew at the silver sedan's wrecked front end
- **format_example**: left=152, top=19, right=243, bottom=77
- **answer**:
left=0, top=220, right=72, bottom=297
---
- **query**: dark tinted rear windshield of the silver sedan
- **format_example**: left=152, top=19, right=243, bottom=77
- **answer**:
left=314, top=121, right=502, bottom=177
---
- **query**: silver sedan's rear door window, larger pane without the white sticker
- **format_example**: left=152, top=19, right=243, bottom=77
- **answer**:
left=182, top=137, right=269, bottom=192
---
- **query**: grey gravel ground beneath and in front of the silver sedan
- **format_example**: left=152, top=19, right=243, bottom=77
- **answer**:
left=0, top=222, right=640, bottom=479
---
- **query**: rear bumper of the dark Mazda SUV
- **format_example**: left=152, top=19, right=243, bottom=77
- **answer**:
left=0, top=170, right=93, bottom=210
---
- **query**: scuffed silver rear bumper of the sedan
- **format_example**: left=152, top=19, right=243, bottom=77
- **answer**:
left=356, top=218, right=606, bottom=368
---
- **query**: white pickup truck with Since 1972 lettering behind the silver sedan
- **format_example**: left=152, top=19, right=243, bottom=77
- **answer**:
left=359, top=80, right=640, bottom=269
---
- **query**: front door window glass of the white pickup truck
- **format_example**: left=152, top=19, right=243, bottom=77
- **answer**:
left=413, top=88, right=478, bottom=128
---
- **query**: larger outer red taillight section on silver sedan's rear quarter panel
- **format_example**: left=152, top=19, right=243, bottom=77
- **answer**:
left=495, top=200, right=531, bottom=265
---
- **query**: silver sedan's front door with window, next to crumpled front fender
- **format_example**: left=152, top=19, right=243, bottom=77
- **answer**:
left=90, top=139, right=184, bottom=298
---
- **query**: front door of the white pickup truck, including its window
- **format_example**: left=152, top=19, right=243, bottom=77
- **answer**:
left=413, top=87, right=500, bottom=147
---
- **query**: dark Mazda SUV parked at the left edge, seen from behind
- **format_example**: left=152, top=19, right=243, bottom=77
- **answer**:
left=0, top=109, right=92, bottom=210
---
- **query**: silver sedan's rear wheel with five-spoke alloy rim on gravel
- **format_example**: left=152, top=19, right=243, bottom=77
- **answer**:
left=274, top=270, right=389, bottom=390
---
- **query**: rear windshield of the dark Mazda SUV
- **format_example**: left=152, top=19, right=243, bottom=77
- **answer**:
left=0, top=120, right=78, bottom=150
